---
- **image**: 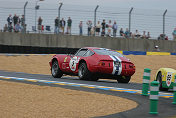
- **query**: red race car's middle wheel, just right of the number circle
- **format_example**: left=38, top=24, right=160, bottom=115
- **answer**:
left=78, top=62, right=98, bottom=81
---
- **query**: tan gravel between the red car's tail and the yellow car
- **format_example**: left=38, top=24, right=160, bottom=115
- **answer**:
left=126, top=55, right=176, bottom=83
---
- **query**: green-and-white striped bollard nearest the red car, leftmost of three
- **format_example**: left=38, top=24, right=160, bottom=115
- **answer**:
left=142, top=68, right=151, bottom=96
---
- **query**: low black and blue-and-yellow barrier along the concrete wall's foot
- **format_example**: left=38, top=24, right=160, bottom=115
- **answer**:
left=0, top=45, right=176, bottom=55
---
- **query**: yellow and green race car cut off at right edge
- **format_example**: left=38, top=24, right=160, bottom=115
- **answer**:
left=155, top=68, right=176, bottom=91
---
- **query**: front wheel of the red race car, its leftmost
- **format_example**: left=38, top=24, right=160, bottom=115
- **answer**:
left=51, top=61, right=63, bottom=78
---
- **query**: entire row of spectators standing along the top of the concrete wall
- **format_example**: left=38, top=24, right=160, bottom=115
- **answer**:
left=3, top=14, right=176, bottom=41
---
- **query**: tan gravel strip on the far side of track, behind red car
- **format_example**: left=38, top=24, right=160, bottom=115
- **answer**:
left=0, top=55, right=176, bottom=83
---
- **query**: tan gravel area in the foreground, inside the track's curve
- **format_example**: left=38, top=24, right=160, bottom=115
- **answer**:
left=0, top=80, right=137, bottom=118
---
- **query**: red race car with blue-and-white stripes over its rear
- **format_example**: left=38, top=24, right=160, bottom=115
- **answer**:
left=49, top=47, right=135, bottom=83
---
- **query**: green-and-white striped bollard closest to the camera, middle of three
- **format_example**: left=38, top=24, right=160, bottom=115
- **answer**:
left=149, top=81, right=159, bottom=114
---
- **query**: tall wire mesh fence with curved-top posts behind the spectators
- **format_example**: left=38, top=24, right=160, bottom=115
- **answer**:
left=0, top=2, right=176, bottom=39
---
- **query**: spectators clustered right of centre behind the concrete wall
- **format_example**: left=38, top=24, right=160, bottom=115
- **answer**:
left=84, top=20, right=151, bottom=39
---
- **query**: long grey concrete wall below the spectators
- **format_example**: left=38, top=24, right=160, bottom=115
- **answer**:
left=0, top=32, right=176, bottom=52
